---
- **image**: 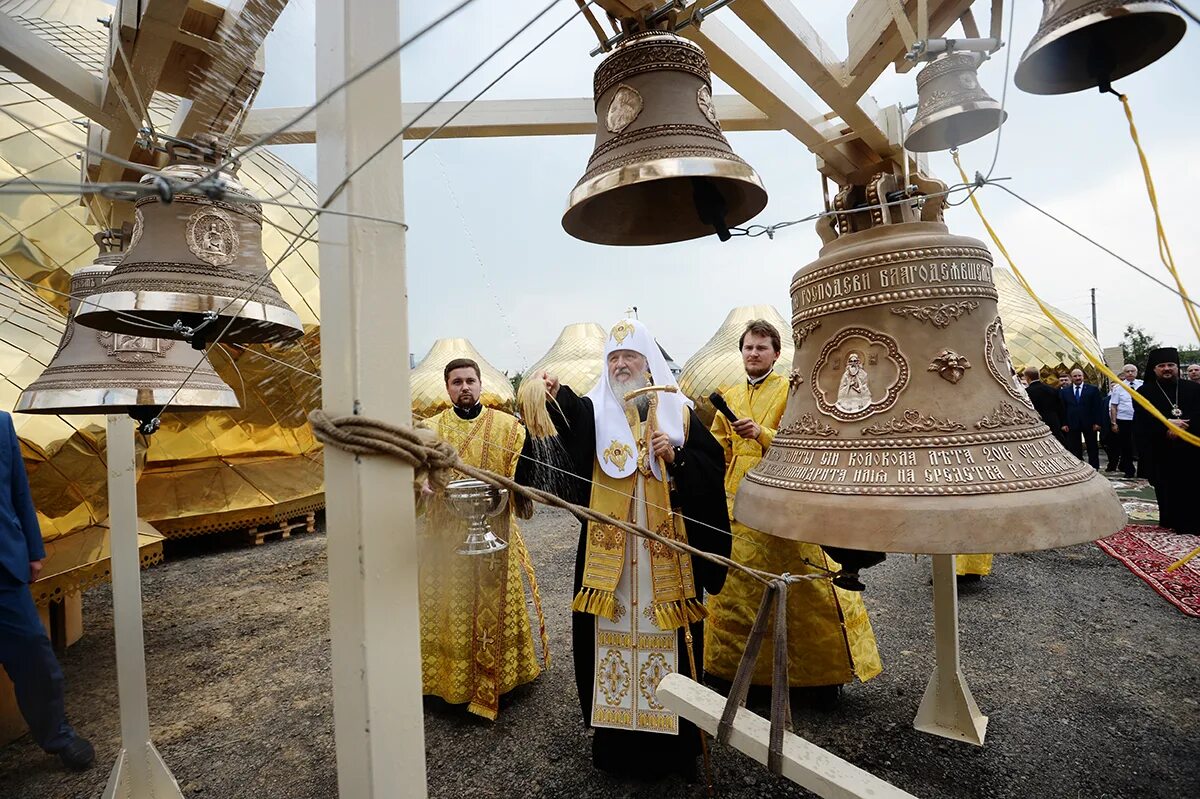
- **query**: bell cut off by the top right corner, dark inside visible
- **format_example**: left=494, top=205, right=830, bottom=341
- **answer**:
left=1013, top=0, right=1187, bottom=95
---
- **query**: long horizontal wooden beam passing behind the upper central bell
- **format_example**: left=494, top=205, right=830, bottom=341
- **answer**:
left=234, top=95, right=781, bottom=145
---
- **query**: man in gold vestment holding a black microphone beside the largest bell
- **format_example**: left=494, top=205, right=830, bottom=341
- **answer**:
left=704, top=319, right=882, bottom=707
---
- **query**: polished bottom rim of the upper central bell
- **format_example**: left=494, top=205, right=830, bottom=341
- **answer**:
left=563, top=156, right=768, bottom=246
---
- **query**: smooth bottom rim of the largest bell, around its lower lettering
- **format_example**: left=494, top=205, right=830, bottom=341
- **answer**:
left=733, top=471, right=1127, bottom=554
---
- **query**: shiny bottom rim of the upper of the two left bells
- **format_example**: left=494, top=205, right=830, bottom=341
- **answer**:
left=74, top=290, right=304, bottom=342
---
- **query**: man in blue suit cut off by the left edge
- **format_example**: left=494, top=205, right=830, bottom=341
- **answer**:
left=0, top=411, right=96, bottom=770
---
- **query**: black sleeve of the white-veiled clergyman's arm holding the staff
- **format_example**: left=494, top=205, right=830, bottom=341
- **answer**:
left=671, top=410, right=733, bottom=594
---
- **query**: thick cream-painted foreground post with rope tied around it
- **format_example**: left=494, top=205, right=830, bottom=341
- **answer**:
left=316, top=0, right=426, bottom=799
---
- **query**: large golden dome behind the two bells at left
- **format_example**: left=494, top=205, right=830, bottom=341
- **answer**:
left=0, top=0, right=324, bottom=541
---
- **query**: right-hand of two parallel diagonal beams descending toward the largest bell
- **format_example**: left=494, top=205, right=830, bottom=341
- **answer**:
left=731, top=0, right=898, bottom=158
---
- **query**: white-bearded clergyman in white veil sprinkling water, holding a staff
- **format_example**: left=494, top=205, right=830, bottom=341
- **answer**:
left=522, top=319, right=731, bottom=779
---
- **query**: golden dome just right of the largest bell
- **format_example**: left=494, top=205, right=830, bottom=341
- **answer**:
left=992, top=268, right=1103, bottom=383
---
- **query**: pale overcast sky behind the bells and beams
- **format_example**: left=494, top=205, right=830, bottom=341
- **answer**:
left=248, top=0, right=1200, bottom=370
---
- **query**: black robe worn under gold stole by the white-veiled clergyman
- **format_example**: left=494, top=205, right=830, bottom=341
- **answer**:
left=517, top=385, right=732, bottom=779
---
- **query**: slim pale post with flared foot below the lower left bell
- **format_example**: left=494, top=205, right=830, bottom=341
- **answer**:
left=103, top=414, right=184, bottom=799
